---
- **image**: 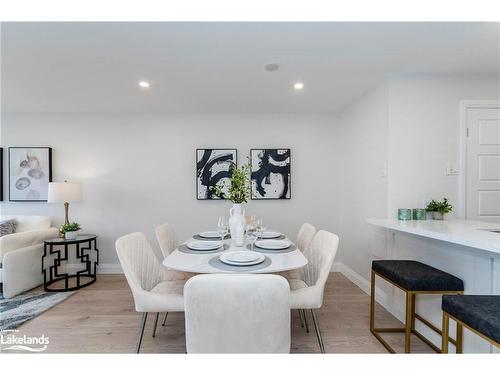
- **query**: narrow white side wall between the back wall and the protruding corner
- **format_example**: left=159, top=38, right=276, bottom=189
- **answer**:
left=338, top=85, right=389, bottom=275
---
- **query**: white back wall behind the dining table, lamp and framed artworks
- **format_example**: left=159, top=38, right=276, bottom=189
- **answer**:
left=0, top=114, right=340, bottom=264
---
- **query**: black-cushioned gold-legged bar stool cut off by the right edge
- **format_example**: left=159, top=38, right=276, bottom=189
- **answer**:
left=441, top=295, right=500, bottom=353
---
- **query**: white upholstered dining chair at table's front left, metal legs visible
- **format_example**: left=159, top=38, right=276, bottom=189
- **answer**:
left=115, top=232, right=186, bottom=353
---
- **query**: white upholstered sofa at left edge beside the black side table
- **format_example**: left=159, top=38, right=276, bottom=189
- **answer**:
left=0, top=215, right=59, bottom=298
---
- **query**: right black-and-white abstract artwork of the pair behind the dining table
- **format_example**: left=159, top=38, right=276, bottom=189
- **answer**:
left=250, top=148, right=291, bottom=199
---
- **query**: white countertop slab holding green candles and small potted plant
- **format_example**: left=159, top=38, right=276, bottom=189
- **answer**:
left=367, top=219, right=500, bottom=254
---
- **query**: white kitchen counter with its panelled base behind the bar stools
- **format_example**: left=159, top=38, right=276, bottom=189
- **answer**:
left=365, top=219, right=500, bottom=353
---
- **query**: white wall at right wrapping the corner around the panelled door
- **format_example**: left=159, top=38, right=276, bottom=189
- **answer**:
left=338, top=76, right=500, bottom=281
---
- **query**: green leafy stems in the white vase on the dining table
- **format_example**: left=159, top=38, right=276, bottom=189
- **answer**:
left=210, top=163, right=251, bottom=204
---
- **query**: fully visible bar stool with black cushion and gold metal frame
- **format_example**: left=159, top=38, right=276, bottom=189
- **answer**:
left=370, top=260, right=464, bottom=353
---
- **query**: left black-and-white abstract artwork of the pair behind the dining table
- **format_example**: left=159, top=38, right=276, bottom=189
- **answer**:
left=196, top=149, right=237, bottom=199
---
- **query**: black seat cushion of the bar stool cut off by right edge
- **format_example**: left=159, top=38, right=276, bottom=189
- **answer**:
left=442, top=295, right=500, bottom=344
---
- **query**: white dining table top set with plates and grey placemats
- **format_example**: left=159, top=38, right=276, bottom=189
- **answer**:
left=163, top=231, right=307, bottom=274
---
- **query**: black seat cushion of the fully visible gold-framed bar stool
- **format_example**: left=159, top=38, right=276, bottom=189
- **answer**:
left=372, top=260, right=464, bottom=291
